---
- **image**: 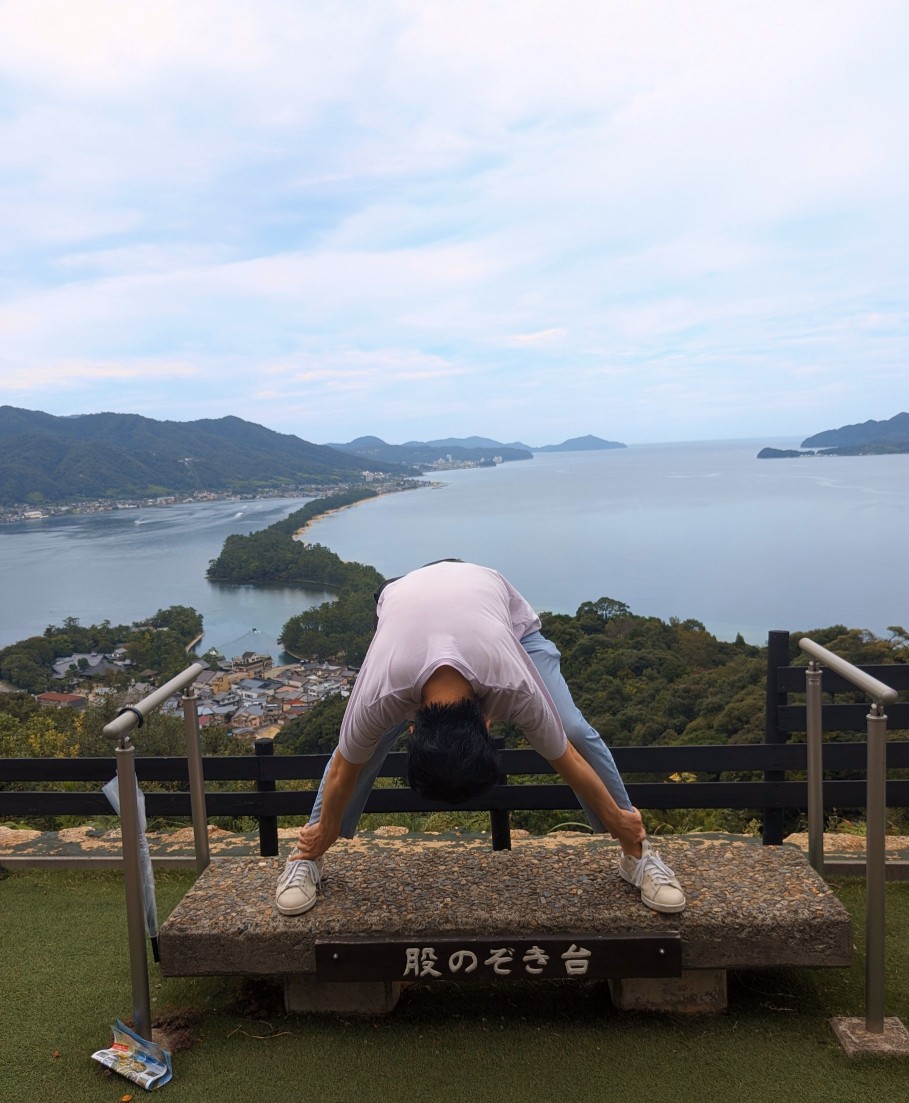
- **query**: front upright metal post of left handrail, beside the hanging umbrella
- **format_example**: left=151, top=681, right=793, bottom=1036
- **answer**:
left=117, top=736, right=151, bottom=1041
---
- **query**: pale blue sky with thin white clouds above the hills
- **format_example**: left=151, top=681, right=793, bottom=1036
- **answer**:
left=0, top=0, right=909, bottom=445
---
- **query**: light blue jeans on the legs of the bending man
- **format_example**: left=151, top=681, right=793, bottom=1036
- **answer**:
left=309, top=632, right=632, bottom=838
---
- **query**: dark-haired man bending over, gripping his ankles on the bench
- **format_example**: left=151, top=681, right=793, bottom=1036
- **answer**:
left=276, top=560, right=685, bottom=915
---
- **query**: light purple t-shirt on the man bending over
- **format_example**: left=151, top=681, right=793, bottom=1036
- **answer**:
left=339, top=563, right=567, bottom=762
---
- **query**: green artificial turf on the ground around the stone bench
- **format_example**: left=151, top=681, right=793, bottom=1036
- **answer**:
left=0, top=871, right=909, bottom=1103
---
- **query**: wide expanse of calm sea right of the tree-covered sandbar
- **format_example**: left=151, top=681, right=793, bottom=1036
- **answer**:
left=295, top=440, right=909, bottom=643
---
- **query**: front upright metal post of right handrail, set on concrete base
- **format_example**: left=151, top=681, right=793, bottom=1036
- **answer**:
left=865, top=705, right=887, bottom=1034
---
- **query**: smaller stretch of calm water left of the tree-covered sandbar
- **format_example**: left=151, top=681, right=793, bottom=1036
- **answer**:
left=0, top=499, right=330, bottom=657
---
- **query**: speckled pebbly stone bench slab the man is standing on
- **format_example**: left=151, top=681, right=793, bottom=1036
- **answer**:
left=160, top=835, right=852, bottom=976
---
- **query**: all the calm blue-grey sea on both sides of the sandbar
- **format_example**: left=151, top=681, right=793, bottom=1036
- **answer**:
left=0, top=440, right=909, bottom=660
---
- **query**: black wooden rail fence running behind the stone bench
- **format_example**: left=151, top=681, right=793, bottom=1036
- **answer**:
left=0, top=632, right=909, bottom=854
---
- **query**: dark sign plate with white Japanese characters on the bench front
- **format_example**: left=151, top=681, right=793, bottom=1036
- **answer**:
left=316, top=933, right=682, bottom=982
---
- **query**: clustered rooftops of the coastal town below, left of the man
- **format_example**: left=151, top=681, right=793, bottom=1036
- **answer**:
left=35, top=649, right=357, bottom=741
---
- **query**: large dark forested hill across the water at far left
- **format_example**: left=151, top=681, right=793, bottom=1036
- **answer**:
left=0, top=406, right=402, bottom=505
